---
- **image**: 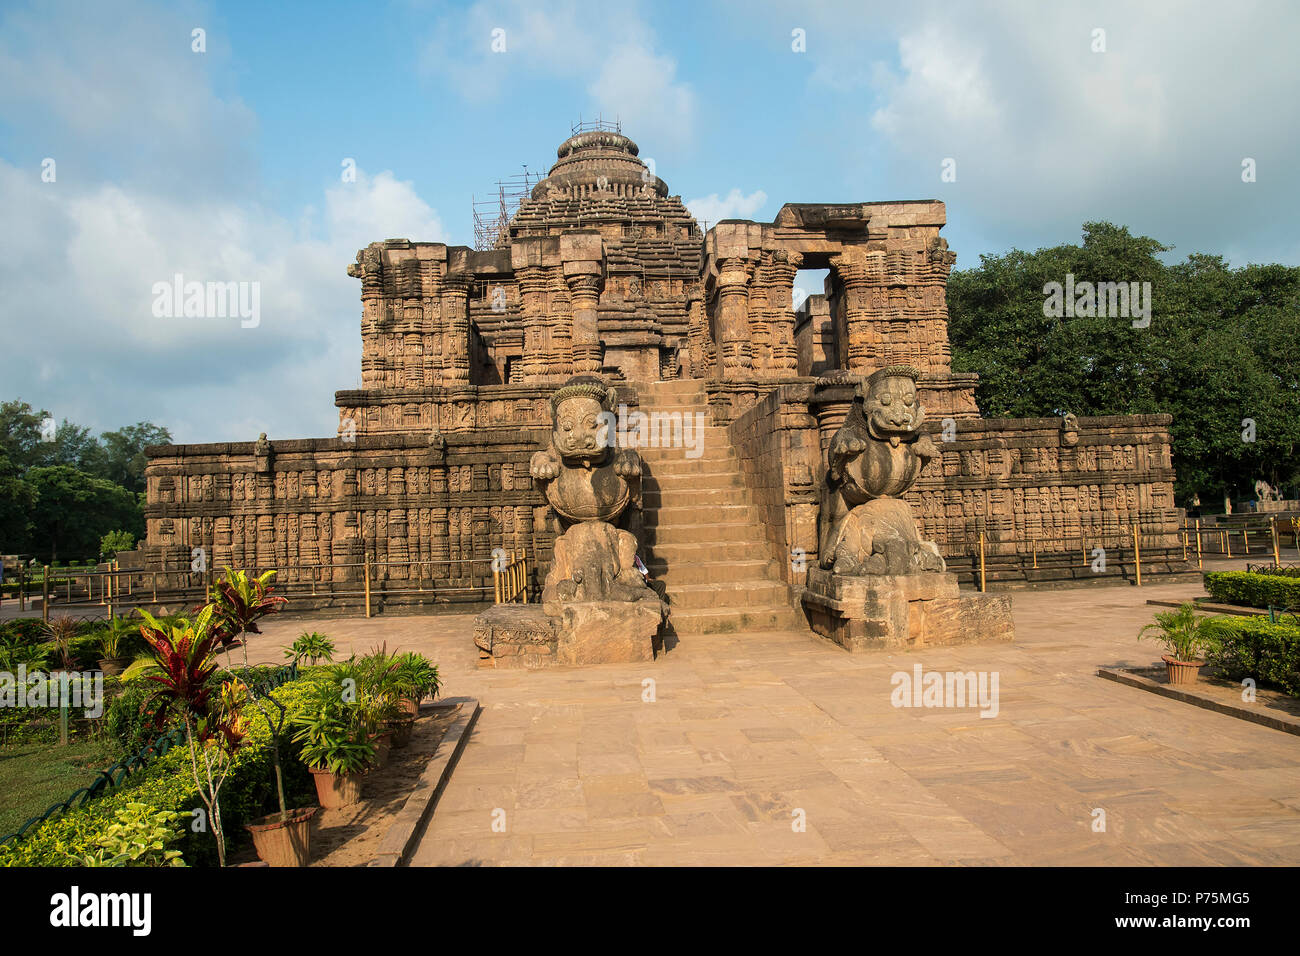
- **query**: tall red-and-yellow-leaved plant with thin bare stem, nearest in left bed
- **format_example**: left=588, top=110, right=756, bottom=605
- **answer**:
left=140, top=606, right=247, bottom=866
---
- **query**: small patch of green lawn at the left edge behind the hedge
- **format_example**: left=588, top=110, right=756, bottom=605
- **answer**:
left=0, top=740, right=116, bottom=836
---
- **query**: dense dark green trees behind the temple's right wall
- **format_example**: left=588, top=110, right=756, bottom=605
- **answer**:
left=948, top=222, right=1300, bottom=503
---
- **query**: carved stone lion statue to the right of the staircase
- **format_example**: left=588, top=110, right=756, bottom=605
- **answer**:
left=819, top=365, right=945, bottom=575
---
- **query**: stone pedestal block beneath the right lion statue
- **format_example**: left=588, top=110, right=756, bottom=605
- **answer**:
left=802, top=568, right=1014, bottom=650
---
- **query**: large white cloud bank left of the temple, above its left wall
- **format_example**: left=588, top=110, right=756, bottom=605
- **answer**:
left=0, top=161, right=445, bottom=441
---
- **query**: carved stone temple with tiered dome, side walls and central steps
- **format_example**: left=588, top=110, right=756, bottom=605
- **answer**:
left=138, top=129, right=1186, bottom=635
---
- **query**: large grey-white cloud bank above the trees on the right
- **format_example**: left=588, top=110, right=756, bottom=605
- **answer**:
left=766, top=0, right=1300, bottom=263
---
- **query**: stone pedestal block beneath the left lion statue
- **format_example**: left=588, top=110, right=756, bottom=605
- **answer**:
left=475, top=600, right=666, bottom=670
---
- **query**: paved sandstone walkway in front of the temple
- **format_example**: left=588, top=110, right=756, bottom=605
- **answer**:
left=244, top=564, right=1300, bottom=866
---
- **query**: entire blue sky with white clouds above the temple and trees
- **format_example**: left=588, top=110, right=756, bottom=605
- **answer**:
left=0, top=0, right=1300, bottom=441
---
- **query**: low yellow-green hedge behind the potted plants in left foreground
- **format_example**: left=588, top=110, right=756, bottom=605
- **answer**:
left=0, top=670, right=330, bottom=866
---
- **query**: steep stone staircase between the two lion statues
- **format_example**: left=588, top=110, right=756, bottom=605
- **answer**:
left=637, top=380, right=807, bottom=635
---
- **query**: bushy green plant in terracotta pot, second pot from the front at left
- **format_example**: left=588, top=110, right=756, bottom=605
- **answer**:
left=294, top=684, right=374, bottom=810
